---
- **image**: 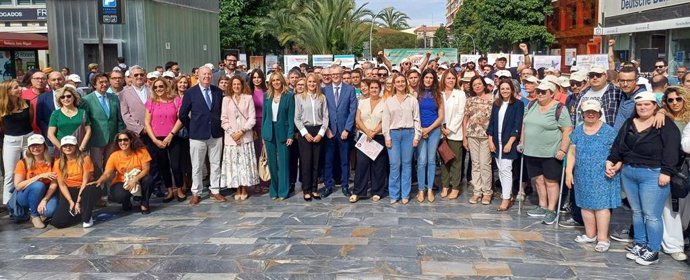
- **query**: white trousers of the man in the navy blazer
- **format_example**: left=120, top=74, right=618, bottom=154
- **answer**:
left=189, top=138, right=223, bottom=195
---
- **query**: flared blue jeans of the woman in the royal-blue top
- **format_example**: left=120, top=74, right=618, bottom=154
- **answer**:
left=416, top=127, right=441, bottom=191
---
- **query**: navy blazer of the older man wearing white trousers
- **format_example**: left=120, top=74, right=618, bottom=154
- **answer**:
left=179, top=84, right=224, bottom=140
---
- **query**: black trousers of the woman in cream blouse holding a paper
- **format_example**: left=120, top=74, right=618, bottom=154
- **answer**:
left=352, top=135, right=390, bottom=197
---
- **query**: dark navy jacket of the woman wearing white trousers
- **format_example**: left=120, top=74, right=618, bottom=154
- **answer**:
left=486, top=100, right=525, bottom=159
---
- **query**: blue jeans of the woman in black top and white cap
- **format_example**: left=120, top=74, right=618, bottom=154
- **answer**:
left=621, top=164, right=671, bottom=252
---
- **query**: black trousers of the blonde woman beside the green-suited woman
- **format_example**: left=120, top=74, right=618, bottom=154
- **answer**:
left=290, top=126, right=325, bottom=194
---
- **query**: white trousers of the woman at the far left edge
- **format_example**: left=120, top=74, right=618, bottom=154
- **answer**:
left=2, top=132, right=34, bottom=204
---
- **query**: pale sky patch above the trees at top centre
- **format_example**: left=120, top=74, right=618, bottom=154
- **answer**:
left=355, top=0, right=446, bottom=26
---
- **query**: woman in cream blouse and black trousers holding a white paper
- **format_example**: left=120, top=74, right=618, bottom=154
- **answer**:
left=350, top=80, right=388, bottom=203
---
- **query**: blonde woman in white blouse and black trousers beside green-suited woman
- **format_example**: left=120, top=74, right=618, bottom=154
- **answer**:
left=295, top=73, right=328, bottom=201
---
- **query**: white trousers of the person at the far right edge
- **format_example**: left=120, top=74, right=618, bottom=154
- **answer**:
left=661, top=195, right=690, bottom=254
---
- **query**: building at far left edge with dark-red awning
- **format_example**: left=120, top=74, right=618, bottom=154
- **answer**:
left=0, top=0, right=48, bottom=80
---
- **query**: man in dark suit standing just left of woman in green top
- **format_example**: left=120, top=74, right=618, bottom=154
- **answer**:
left=35, top=71, right=65, bottom=154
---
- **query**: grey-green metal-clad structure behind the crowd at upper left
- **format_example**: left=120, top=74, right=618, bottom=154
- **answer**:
left=47, top=0, right=220, bottom=82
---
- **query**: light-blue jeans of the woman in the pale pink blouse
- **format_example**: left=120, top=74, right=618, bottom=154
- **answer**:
left=388, top=128, right=414, bottom=200
